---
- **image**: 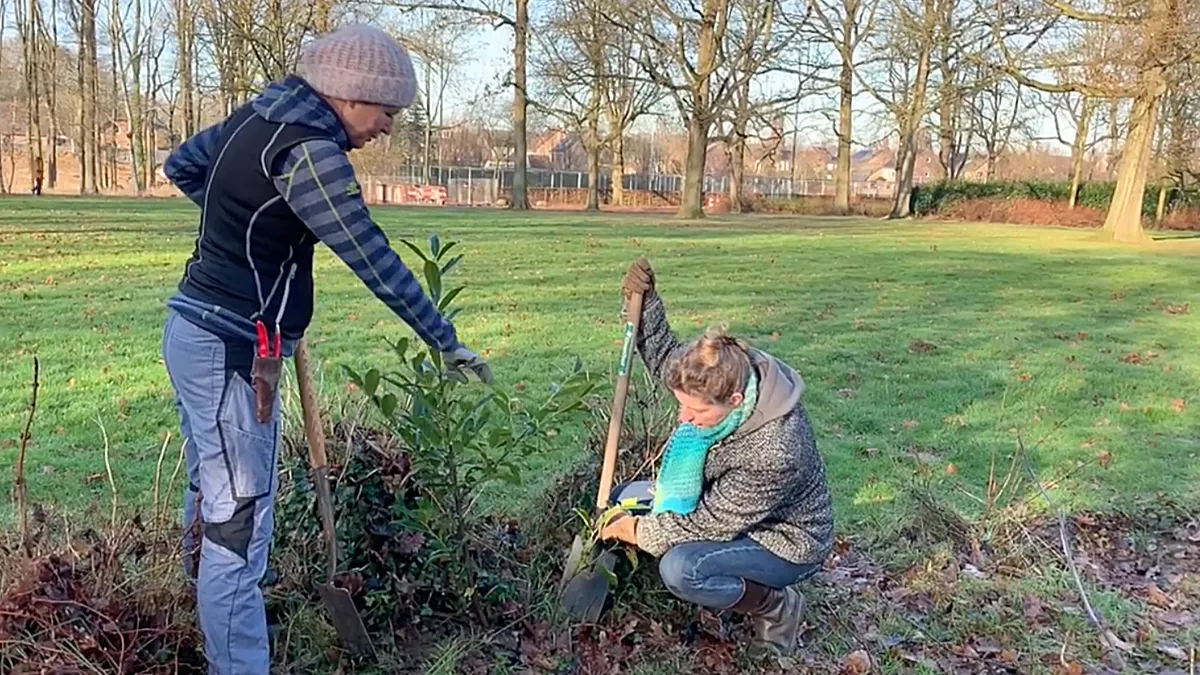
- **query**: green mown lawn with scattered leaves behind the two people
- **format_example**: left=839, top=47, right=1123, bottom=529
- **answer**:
left=0, top=197, right=1200, bottom=532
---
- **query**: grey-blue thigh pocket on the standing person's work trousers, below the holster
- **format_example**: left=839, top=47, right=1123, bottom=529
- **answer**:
left=217, top=375, right=280, bottom=500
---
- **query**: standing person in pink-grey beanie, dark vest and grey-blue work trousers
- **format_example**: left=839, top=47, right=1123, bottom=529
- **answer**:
left=162, top=25, right=491, bottom=675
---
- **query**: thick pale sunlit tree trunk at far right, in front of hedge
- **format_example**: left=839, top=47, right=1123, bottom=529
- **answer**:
left=1104, top=72, right=1166, bottom=244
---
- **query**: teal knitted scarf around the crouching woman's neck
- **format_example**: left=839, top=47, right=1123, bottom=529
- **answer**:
left=653, top=370, right=758, bottom=515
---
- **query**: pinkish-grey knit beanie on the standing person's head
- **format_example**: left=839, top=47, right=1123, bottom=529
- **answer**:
left=296, top=24, right=416, bottom=108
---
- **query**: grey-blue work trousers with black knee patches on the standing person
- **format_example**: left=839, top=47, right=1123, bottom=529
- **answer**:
left=162, top=310, right=280, bottom=675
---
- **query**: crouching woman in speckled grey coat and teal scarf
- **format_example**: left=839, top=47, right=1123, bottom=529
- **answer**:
left=601, top=258, right=833, bottom=656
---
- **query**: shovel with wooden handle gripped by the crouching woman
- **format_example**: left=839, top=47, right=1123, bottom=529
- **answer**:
left=559, top=285, right=642, bottom=623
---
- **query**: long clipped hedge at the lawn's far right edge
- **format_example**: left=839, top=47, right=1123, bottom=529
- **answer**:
left=912, top=180, right=1200, bottom=216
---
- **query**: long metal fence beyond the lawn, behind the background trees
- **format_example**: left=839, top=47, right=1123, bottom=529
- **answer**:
left=365, top=166, right=892, bottom=205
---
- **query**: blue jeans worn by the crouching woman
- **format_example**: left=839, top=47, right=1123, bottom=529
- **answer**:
left=610, top=480, right=820, bottom=609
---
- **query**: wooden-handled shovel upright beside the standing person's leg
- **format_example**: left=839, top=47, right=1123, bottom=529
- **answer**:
left=295, top=340, right=374, bottom=655
